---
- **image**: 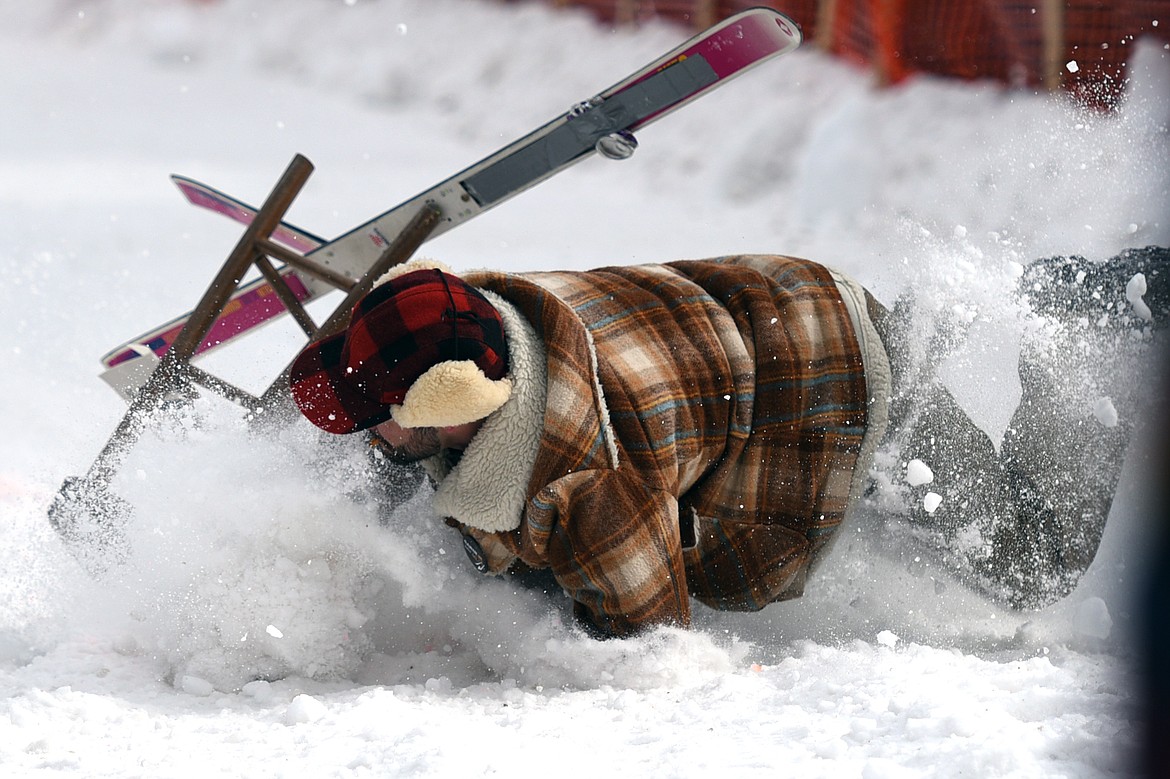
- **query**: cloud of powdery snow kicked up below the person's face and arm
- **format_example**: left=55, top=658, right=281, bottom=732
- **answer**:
left=52, top=399, right=746, bottom=690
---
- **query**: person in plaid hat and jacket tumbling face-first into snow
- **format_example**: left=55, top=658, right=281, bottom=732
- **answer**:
left=290, top=248, right=1170, bottom=636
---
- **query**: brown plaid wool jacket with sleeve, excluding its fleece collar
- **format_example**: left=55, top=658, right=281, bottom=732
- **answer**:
left=451, top=256, right=867, bottom=635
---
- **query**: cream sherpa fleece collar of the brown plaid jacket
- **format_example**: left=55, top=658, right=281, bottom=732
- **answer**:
left=424, top=288, right=548, bottom=532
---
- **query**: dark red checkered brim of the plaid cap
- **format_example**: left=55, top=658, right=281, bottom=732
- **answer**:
left=289, top=332, right=391, bottom=434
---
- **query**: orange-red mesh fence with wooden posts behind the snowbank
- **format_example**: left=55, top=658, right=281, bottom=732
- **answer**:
left=535, top=0, right=1170, bottom=106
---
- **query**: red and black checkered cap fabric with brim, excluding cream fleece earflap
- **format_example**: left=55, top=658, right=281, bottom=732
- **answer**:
left=289, top=268, right=508, bottom=433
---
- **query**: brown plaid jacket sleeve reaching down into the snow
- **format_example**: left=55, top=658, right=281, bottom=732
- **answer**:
left=527, top=470, right=690, bottom=636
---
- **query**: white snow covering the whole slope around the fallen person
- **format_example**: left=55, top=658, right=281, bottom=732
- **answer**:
left=0, top=0, right=1170, bottom=778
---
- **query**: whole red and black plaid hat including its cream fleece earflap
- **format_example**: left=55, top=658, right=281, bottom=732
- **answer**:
left=289, top=262, right=511, bottom=433
